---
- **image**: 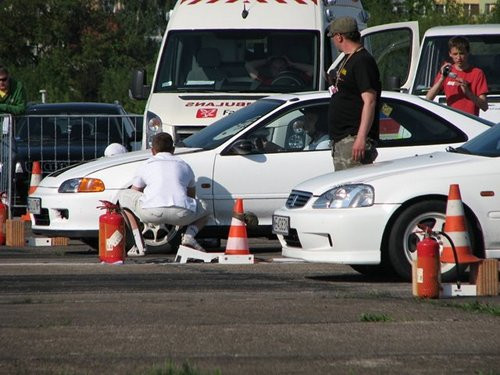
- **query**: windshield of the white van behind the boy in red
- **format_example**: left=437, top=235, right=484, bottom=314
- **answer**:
left=412, top=35, right=500, bottom=95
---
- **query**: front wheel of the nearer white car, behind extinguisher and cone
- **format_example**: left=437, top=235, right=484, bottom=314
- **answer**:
left=388, top=200, right=476, bottom=281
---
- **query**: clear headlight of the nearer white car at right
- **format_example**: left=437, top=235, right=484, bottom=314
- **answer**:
left=313, top=184, right=375, bottom=208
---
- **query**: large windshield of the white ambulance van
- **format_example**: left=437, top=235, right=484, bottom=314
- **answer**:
left=154, top=30, right=320, bottom=93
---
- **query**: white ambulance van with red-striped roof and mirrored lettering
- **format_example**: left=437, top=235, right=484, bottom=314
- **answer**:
left=131, top=0, right=367, bottom=148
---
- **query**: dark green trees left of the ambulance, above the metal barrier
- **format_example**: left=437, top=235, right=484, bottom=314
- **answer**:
left=0, top=0, right=173, bottom=113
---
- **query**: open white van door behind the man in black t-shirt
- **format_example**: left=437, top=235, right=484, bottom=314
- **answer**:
left=329, top=21, right=420, bottom=92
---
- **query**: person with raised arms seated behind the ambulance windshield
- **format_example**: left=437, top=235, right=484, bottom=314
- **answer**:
left=245, top=55, right=313, bottom=85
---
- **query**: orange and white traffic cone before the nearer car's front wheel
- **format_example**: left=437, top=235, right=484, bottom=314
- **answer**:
left=441, top=184, right=481, bottom=264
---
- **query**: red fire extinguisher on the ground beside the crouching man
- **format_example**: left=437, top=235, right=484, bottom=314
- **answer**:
left=98, top=201, right=125, bottom=264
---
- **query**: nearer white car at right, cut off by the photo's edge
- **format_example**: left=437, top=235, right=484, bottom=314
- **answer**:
left=273, top=124, right=500, bottom=280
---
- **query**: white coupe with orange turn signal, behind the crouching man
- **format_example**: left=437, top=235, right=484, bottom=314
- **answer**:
left=28, top=92, right=492, bottom=253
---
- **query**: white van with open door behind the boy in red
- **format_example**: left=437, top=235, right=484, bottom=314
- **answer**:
left=354, top=22, right=500, bottom=123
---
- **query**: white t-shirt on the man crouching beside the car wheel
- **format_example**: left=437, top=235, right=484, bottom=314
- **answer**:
left=133, top=152, right=196, bottom=211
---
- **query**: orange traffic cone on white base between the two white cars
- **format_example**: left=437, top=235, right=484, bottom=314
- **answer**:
left=219, top=198, right=254, bottom=264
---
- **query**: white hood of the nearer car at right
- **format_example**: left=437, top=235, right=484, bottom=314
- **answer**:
left=294, top=152, right=481, bottom=196
